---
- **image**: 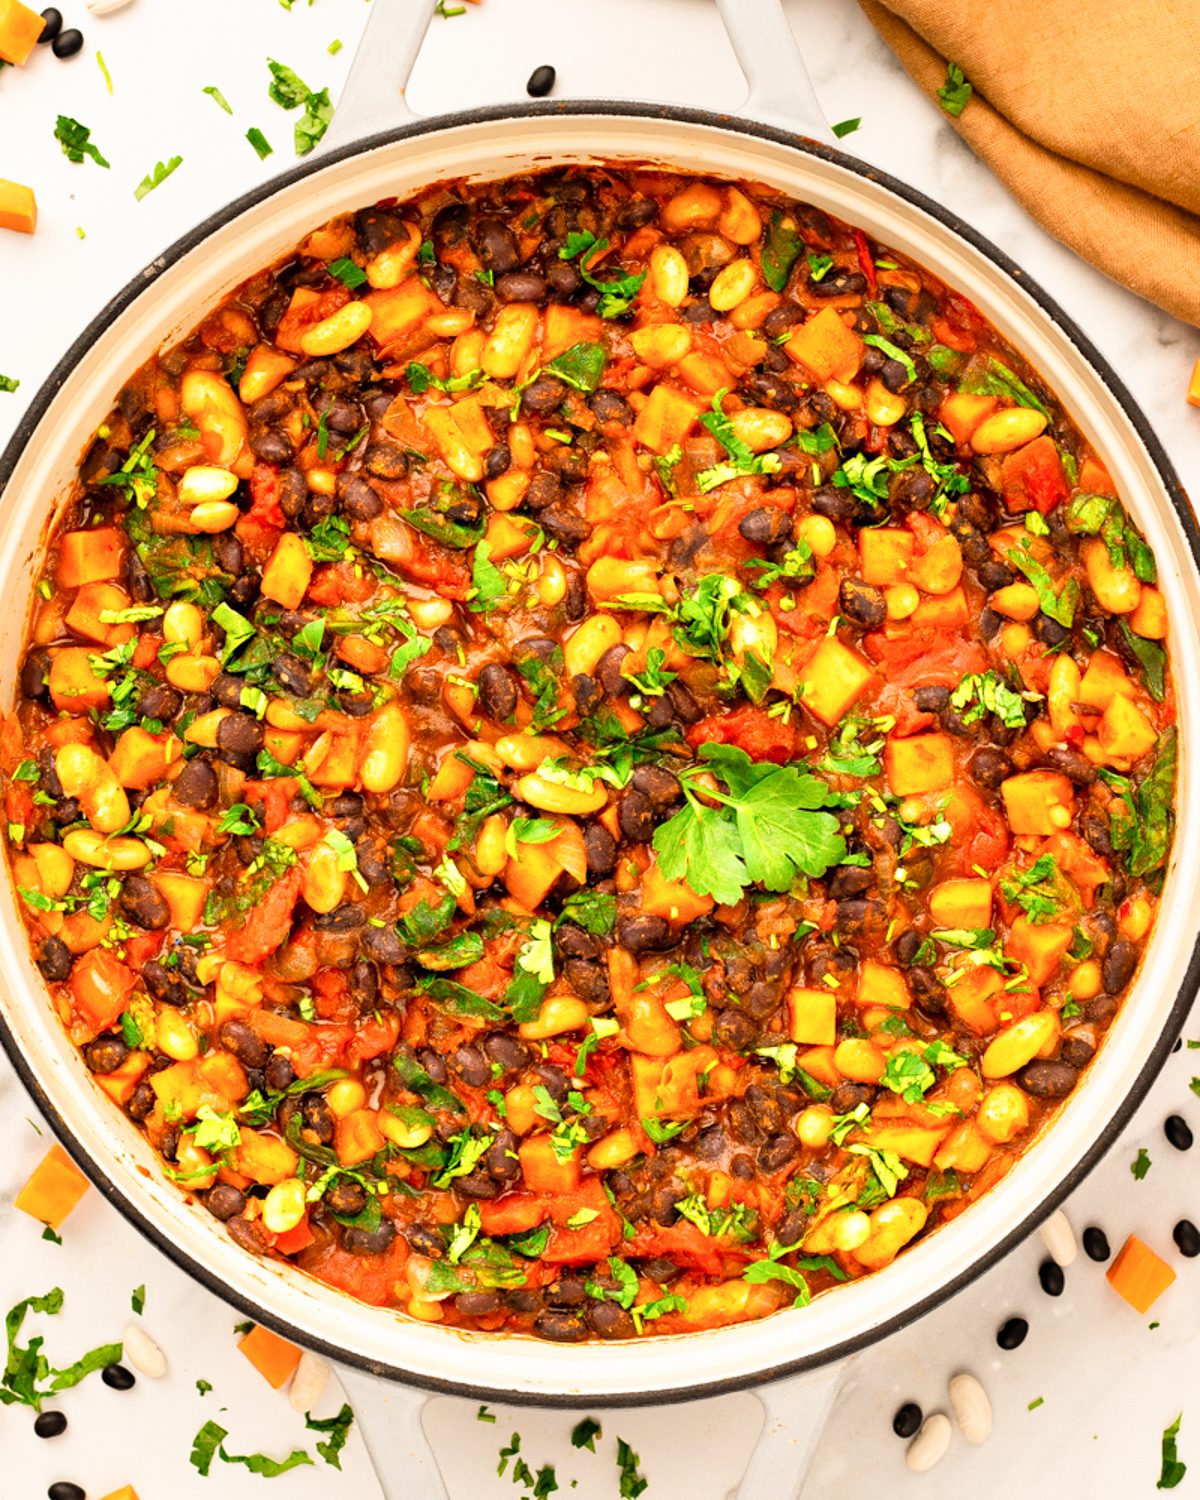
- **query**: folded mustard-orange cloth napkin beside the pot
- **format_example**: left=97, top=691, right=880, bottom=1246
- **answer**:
left=858, top=0, right=1200, bottom=326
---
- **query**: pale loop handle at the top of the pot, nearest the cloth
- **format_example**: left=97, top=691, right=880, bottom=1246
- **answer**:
left=321, top=0, right=834, bottom=150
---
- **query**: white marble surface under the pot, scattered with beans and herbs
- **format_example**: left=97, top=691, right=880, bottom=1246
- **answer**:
left=0, top=0, right=1200, bottom=1500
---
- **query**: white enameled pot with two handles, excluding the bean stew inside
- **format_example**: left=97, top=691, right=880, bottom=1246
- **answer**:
left=0, top=0, right=1200, bottom=1500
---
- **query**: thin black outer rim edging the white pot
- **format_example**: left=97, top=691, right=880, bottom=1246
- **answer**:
left=0, top=99, right=1200, bottom=1407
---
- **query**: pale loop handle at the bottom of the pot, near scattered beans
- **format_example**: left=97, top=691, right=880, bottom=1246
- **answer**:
left=336, top=1361, right=851, bottom=1500
